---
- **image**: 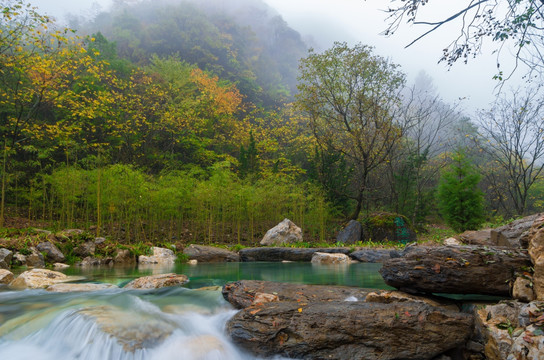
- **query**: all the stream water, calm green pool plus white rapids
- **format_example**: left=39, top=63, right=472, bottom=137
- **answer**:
left=0, top=263, right=387, bottom=360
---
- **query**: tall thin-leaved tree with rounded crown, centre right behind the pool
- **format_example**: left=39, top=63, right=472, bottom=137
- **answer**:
left=296, top=43, right=408, bottom=219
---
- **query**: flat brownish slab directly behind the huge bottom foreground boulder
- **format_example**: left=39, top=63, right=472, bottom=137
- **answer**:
left=222, top=280, right=374, bottom=309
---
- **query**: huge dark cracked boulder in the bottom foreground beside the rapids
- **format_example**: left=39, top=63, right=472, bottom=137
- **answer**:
left=226, top=301, right=472, bottom=360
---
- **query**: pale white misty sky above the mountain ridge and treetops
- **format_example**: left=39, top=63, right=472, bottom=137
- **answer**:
left=32, top=0, right=522, bottom=116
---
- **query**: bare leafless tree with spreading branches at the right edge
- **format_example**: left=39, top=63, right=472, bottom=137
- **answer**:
left=478, top=89, right=544, bottom=215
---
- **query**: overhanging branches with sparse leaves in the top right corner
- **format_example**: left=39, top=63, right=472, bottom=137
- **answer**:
left=384, top=0, right=544, bottom=80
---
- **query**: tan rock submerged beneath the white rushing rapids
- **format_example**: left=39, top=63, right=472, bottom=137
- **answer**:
left=74, top=306, right=176, bottom=352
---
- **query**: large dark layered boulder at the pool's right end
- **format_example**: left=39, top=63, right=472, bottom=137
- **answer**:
left=380, top=246, right=531, bottom=296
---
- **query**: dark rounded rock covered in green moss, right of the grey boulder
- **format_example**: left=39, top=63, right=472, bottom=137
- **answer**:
left=362, top=212, right=417, bottom=244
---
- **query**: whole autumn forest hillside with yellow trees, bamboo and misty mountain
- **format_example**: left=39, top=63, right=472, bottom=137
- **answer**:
left=0, top=0, right=544, bottom=244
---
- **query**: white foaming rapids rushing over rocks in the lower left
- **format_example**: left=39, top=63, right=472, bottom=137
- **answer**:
left=0, top=288, right=286, bottom=360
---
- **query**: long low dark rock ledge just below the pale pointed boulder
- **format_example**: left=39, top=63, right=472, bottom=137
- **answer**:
left=239, top=247, right=350, bottom=262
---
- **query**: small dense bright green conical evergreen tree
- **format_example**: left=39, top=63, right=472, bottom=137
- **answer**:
left=438, top=150, right=484, bottom=232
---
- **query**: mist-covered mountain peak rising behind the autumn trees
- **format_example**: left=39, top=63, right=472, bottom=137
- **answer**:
left=80, top=0, right=307, bottom=105
